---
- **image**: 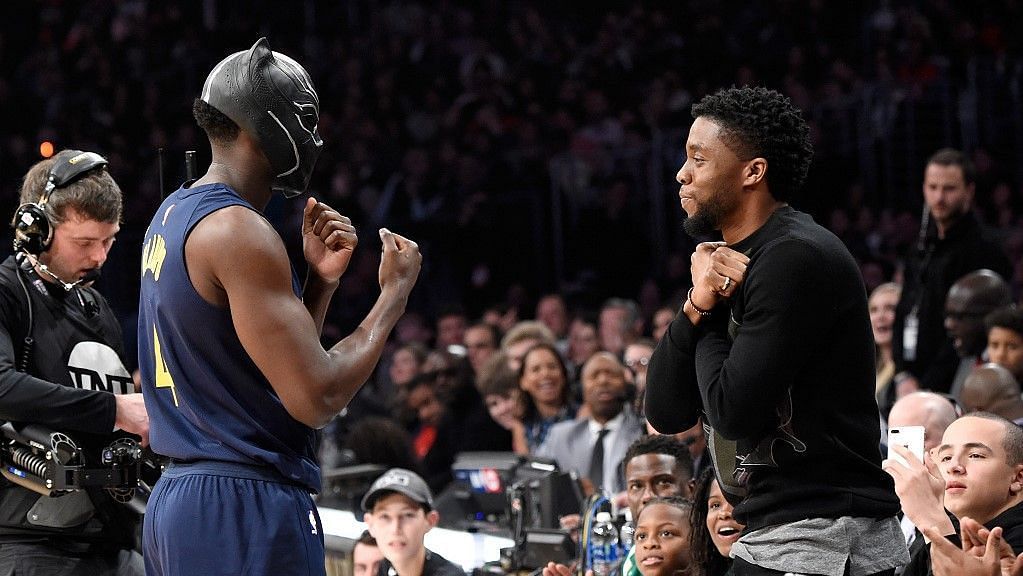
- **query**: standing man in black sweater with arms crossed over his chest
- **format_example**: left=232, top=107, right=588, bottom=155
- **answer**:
left=646, top=88, right=908, bottom=576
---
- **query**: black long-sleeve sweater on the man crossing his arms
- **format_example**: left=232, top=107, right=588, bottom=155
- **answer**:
left=646, top=207, right=898, bottom=529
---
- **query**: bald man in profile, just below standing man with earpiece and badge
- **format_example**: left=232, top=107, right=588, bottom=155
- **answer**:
left=945, top=270, right=1012, bottom=398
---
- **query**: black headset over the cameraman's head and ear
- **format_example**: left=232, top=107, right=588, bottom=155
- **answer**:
left=10, top=150, right=106, bottom=256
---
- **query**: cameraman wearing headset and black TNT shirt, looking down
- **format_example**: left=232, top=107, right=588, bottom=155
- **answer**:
left=0, top=150, right=149, bottom=576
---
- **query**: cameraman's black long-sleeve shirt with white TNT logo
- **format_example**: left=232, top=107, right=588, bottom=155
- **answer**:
left=0, top=257, right=137, bottom=548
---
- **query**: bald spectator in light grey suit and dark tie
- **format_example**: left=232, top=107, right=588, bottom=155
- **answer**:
left=537, top=352, right=643, bottom=494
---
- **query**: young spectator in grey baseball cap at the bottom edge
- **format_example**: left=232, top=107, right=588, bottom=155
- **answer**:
left=362, top=468, right=465, bottom=576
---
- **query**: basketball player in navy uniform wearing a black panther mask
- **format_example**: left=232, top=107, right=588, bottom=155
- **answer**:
left=138, top=39, right=421, bottom=576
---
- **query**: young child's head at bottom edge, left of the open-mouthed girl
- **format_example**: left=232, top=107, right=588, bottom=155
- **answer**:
left=632, top=496, right=693, bottom=576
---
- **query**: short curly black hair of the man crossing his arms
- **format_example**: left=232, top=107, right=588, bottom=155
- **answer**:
left=693, top=87, right=813, bottom=202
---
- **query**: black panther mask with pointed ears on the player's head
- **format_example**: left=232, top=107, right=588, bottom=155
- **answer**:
left=202, top=38, right=323, bottom=197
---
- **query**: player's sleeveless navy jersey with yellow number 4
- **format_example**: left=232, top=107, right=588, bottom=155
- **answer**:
left=138, top=184, right=320, bottom=492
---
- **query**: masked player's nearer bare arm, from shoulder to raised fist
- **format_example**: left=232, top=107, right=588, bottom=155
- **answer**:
left=185, top=207, right=421, bottom=428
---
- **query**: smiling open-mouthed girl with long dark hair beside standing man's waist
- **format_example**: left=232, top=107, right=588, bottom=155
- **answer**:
left=690, top=469, right=744, bottom=576
